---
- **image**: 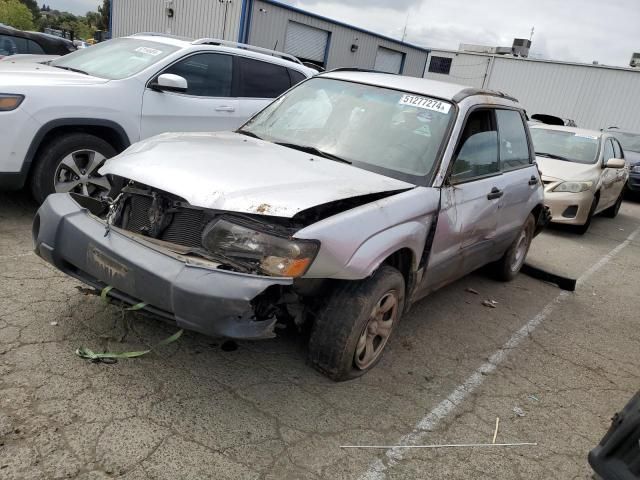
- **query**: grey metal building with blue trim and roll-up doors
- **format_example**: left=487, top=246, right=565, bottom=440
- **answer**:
left=111, top=0, right=429, bottom=77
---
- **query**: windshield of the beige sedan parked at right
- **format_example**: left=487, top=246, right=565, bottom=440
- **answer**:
left=531, top=128, right=599, bottom=164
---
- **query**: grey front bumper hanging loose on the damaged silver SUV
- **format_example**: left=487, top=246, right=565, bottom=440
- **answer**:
left=33, top=194, right=293, bottom=339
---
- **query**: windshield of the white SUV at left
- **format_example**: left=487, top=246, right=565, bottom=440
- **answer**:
left=50, top=38, right=179, bottom=80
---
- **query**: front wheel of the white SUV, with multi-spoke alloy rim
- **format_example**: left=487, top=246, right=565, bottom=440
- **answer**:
left=31, top=133, right=117, bottom=203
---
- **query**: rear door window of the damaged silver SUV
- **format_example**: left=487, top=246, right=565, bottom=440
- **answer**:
left=496, top=110, right=531, bottom=171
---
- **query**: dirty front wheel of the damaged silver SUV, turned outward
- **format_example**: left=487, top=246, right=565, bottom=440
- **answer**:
left=309, top=265, right=405, bottom=381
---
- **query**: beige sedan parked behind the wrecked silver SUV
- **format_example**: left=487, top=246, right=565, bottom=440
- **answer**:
left=531, top=125, right=628, bottom=233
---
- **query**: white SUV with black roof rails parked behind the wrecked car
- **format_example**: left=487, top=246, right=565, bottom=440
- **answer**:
left=0, top=34, right=317, bottom=202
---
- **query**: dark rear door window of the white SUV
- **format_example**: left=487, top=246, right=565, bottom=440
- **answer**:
left=234, top=57, right=291, bottom=98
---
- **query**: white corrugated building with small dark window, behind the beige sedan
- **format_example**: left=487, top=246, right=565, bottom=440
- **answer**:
left=424, top=50, right=640, bottom=132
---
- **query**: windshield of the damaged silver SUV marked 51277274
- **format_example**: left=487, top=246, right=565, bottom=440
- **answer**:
left=240, top=77, right=454, bottom=185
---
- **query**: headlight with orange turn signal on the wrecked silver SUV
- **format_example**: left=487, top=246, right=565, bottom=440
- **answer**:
left=202, top=219, right=320, bottom=277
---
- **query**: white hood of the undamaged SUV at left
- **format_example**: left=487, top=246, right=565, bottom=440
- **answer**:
left=0, top=61, right=109, bottom=87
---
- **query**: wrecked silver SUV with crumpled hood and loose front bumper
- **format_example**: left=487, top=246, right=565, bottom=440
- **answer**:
left=33, top=70, right=545, bottom=380
